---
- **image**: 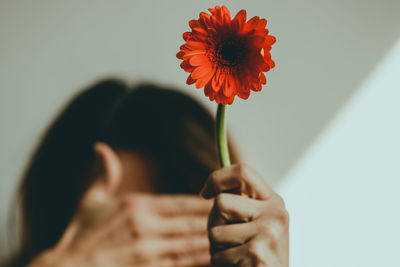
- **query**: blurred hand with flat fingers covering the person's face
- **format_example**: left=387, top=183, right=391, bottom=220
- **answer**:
left=29, top=193, right=212, bottom=267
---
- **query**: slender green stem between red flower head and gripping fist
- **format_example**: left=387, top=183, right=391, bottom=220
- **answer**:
left=215, top=104, right=231, bottom=168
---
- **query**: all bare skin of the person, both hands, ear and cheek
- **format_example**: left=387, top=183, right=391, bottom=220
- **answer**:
left=28, top=143, right=288, bottom=267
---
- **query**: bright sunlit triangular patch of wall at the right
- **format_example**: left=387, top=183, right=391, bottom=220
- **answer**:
left=277, top=38, right=400, bottom=267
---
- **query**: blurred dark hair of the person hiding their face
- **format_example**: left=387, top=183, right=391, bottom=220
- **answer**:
left=4, top=79, right=237, bottom=263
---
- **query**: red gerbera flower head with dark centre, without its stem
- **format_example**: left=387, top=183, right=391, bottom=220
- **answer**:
left=176, top=6, right=276, bottom=105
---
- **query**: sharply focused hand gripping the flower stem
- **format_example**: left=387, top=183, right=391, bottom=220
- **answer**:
left=202, top=164, right=289, bottom=267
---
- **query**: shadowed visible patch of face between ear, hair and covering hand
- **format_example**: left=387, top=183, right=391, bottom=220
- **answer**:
left=114, top=151, right=160, bottom=195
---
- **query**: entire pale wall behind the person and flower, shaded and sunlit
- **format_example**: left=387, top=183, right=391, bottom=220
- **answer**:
left=0, top=0, right=400, bottom=266
